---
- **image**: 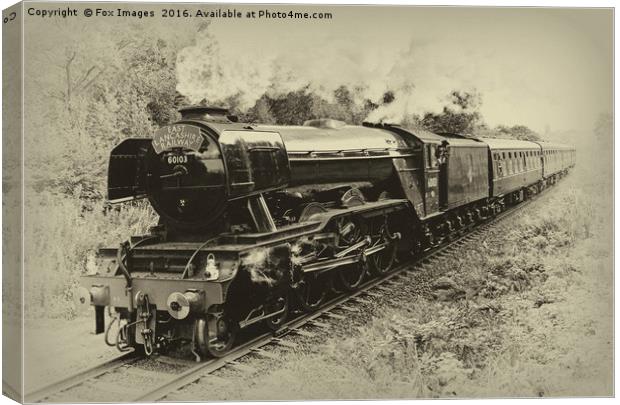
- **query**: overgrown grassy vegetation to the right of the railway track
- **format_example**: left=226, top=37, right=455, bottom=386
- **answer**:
left=166, top=170, right=613, bottom=400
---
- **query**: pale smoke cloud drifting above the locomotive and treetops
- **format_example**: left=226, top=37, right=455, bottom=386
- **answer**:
left=177, top=31, right=488, bottom=122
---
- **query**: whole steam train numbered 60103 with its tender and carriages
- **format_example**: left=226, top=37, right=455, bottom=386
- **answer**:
left=78, top=106, right=575, bottom=358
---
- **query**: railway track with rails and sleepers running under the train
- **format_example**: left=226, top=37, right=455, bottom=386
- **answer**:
left=25, top=181, right=556, bottom=403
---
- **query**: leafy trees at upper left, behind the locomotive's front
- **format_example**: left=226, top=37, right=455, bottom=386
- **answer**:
left=25, top=23, right=193, bottom=204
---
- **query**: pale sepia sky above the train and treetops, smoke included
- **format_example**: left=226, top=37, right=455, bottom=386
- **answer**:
left=180, top=6, right=613, bottom=133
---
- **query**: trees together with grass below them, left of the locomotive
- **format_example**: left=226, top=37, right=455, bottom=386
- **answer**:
left=25, top=22, right=196, bottom=317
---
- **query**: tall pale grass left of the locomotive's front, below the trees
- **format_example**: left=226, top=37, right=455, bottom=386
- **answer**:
left=24, top=192, right=157, bottom=319
